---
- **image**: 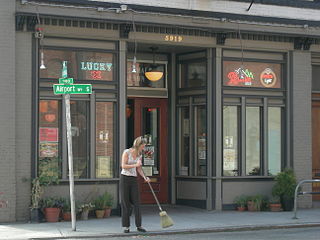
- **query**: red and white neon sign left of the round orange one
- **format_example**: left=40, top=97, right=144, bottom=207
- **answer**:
left=227, top=67, right=254, bottom=86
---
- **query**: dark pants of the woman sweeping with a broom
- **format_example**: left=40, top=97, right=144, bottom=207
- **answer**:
left=120, top=174, right=141, bottom=227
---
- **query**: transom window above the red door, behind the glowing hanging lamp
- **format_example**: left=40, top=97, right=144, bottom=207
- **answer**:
left=127, top=61, right=166, bottom=88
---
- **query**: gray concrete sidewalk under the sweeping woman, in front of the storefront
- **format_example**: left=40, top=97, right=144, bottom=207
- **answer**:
left=0, top=206, right=320, bottom=240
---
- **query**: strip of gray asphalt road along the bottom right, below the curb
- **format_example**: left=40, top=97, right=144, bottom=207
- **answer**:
left=58, top=227, right=320, bottom=240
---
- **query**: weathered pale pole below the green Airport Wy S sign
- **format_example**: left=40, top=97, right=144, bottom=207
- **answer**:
left=63, top=94, right=76, bottom=231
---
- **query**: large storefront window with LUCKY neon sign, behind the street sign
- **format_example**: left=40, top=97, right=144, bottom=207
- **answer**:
left=38, top=46, right=117, bottom=179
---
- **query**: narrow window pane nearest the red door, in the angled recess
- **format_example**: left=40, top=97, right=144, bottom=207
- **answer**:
left=179, top=107, right=190, bottom=175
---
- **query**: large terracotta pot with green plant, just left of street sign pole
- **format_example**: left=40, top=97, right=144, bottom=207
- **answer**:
left=40, top=197, right=63, bottom=222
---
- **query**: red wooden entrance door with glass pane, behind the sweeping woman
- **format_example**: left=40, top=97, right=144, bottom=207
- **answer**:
left=127, top=98, right=168, bottom=204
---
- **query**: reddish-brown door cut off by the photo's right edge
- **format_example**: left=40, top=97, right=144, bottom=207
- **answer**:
left=312, top=101, right=320, bottom=201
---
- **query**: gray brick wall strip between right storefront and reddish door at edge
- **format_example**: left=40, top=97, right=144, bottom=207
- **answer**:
left=291, top=51, right=312, bottom=207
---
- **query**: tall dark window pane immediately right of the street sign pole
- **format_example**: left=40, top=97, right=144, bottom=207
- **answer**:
left=70, top=101, right=89, bottom=178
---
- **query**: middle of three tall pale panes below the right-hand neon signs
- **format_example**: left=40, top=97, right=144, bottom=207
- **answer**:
left=246, top=107, right=261, bottom=175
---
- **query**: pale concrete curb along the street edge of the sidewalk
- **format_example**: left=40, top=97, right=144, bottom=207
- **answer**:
left=29, top=223, right=320, bottom=240
